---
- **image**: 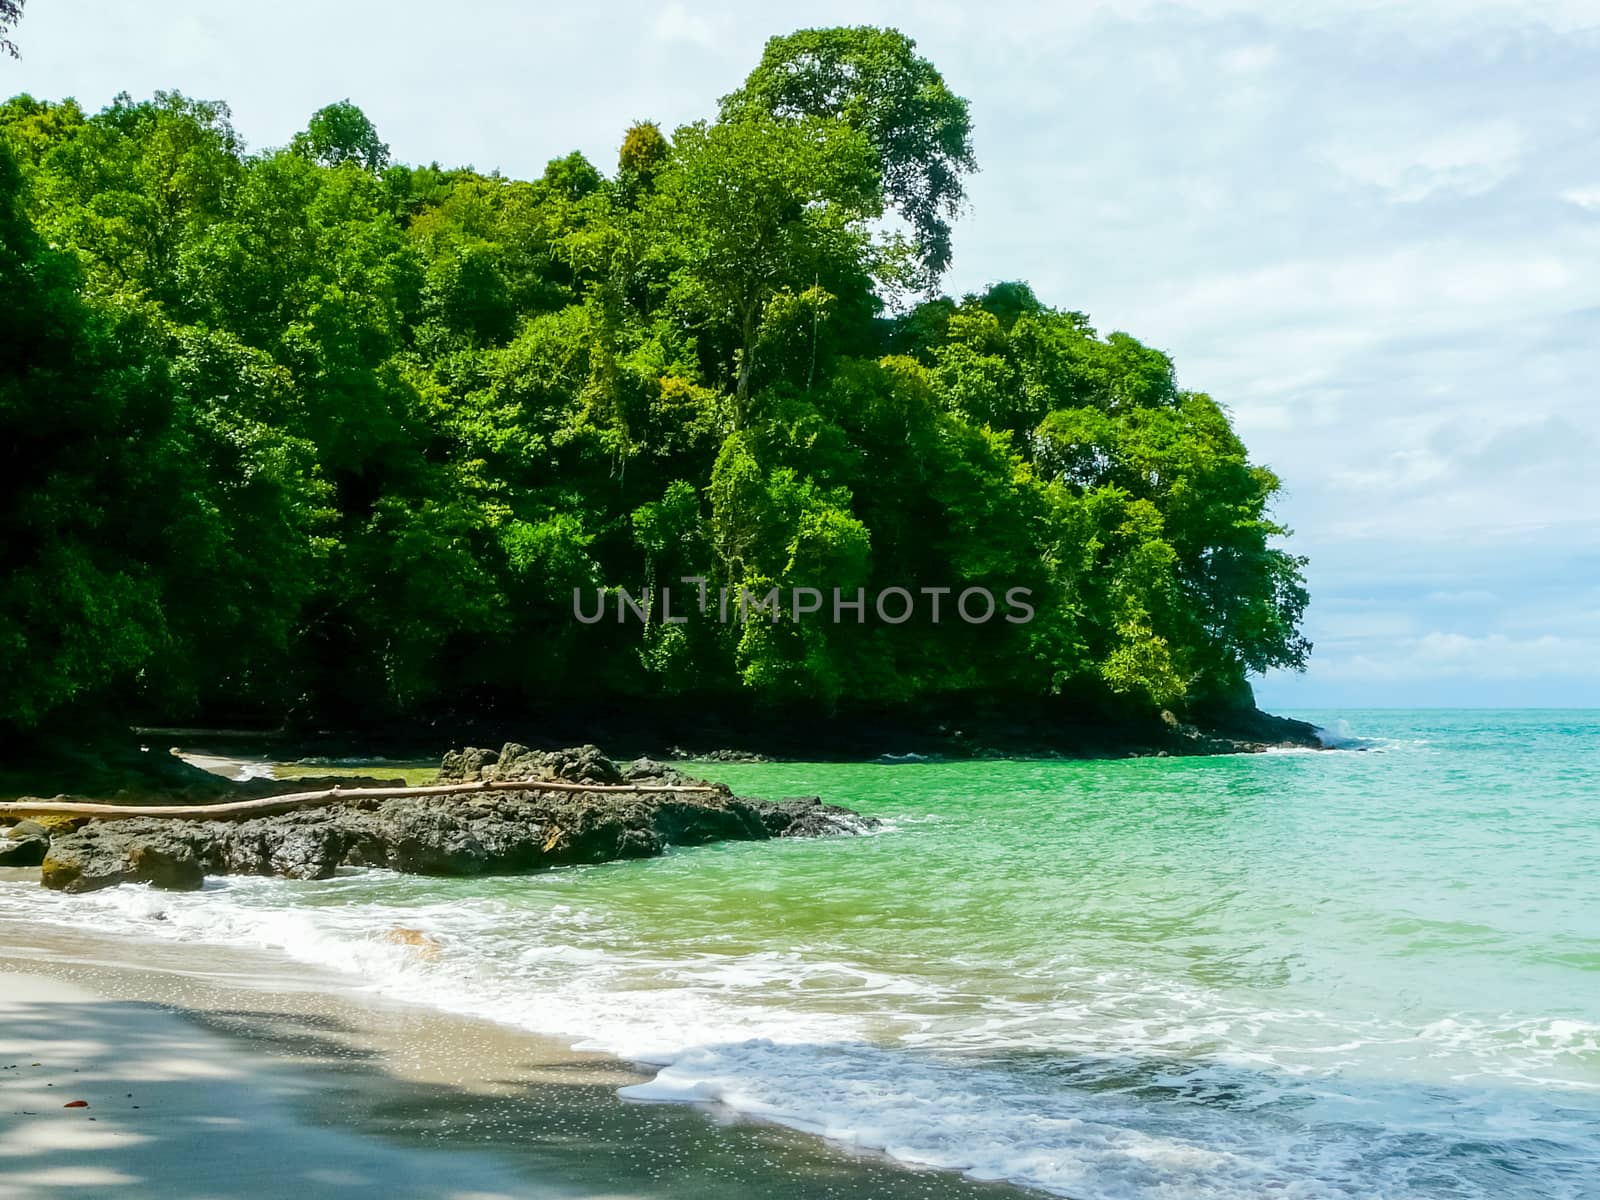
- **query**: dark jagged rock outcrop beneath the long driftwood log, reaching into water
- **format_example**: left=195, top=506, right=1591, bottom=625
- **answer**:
left=42, top=744, right=877, bottom=891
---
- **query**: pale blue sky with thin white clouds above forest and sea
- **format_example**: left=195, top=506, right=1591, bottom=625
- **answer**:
left=0, top=0, right=1600, bottom=709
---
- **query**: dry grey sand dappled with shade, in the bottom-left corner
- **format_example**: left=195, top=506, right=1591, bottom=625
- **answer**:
left=0, top=971, right=537, bottom=1200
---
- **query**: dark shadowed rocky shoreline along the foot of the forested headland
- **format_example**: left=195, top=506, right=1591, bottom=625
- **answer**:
left=0, top=701, right=1336, bottom=803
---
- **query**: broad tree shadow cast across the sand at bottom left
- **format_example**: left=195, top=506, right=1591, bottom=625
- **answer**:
left=0, top=998, right=1024, bottom=1200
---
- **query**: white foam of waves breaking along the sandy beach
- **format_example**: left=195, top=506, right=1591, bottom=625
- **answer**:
left=0, top=872, right=1600, bottom=1200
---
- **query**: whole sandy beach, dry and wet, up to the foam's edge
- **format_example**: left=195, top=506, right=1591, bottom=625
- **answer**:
left=0, top=922, right=1038, bottom=1200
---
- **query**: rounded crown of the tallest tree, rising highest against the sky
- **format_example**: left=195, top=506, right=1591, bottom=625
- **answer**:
left=722, top=26, right=978, bottom=291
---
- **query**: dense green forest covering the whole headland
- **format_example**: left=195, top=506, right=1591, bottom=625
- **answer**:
left=0, top=29, right=1309, bottom=739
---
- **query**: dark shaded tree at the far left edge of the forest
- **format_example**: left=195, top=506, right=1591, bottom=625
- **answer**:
left=0, top=141, right=179, bottom=728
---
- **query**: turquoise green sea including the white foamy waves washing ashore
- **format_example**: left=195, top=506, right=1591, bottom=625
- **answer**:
left=0, top=710, right=1600, bottom=1200
